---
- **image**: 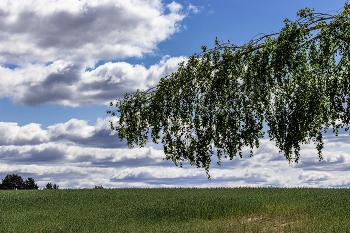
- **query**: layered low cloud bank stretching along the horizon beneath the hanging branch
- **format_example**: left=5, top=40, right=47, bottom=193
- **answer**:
left=0, top=124, right=350, bottom=188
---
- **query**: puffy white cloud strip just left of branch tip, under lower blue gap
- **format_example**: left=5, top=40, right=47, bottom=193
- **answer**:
left=0, top=118, right=126, bottom=148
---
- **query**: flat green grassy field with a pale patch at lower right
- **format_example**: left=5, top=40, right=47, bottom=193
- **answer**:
left=0, top=188, right=350, bottom=232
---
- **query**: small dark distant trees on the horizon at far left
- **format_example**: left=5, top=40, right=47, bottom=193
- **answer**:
left=0, top=174, right=59, bottom=190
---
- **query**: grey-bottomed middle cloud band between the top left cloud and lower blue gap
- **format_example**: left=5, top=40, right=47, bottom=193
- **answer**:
left=0, top=56, right=186, bottom=106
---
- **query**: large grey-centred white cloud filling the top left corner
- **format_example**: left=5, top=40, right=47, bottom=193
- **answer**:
left=0, top=0, right=185, bottom=66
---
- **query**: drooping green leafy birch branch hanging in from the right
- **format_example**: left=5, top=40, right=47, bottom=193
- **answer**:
left=107, top=3, right=350, bottom=175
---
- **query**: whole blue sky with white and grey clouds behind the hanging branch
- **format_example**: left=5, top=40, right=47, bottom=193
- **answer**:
left=0, top=0, right=350, bottom=188
